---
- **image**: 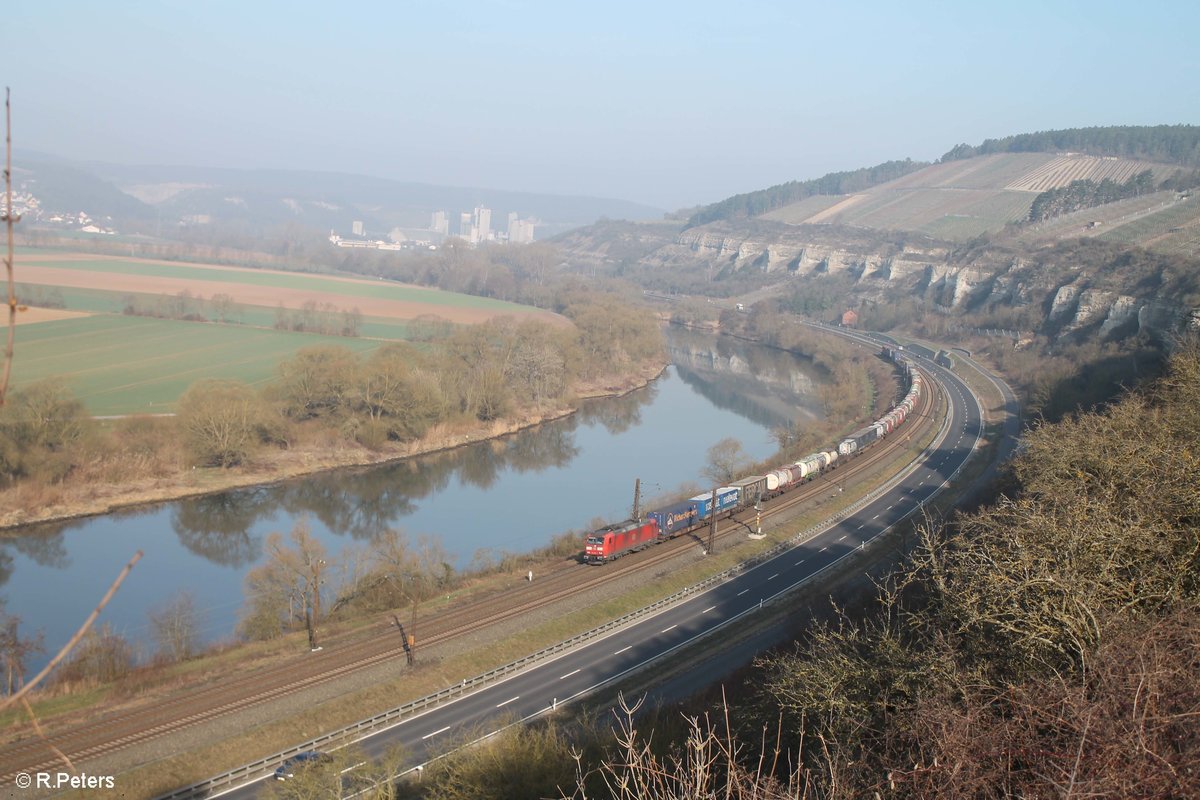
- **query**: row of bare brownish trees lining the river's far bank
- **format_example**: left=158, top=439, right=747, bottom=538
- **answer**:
left=0, top=294, right=664, bottom=482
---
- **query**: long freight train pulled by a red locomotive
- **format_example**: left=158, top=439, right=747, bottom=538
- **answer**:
left=583, top=347, right=923, bottom=564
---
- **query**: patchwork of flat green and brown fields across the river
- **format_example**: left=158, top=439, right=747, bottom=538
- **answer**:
left=2, top=251, right=565, bottom=415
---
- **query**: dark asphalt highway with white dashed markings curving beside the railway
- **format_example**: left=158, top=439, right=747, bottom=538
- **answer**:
left=212, top=357, right=983, bottom=800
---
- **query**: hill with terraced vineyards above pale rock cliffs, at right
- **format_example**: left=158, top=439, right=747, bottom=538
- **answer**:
left=557, top=126, right=1200, bottom=362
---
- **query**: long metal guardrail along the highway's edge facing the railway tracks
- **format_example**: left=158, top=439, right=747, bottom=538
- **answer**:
left=156, top=364, right=961, bottom=800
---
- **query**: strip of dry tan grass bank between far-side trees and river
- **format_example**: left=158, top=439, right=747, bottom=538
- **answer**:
left=0, top=361, right=668, bottom=536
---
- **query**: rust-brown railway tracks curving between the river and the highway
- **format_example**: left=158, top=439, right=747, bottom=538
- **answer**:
left=0, top=375, right=941, bottom=782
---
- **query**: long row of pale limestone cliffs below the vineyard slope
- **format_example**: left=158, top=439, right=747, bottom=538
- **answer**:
left=564, top=219, right=1200, bottom=339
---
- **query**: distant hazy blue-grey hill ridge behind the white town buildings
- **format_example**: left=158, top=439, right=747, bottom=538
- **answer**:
left=13, top=155, right=662, bottom=239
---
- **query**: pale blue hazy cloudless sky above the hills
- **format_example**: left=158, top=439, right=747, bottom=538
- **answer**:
left=9, top=0, right=1200, bottom=209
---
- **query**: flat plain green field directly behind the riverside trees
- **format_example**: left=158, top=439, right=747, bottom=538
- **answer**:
left=12, top=314, right=382, bottom=415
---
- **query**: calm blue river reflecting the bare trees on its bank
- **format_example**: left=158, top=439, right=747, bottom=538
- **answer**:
left=0, top=330, right=818, bottom=669
